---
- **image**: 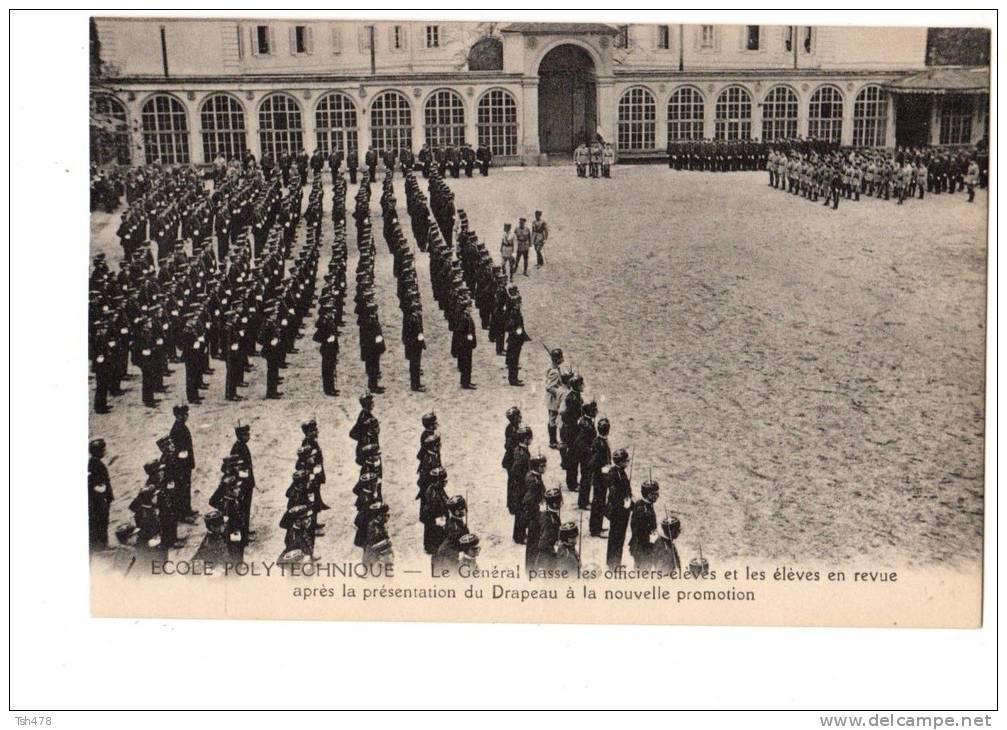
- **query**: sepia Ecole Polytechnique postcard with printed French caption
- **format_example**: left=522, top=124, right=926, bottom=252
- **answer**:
left=80, top=11, right=991, bottom=627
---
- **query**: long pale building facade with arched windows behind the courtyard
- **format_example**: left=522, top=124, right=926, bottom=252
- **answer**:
left=92, top=18, right=989, bottom=164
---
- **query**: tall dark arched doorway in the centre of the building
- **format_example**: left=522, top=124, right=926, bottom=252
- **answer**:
left=539, top=44, right=598, bottom=154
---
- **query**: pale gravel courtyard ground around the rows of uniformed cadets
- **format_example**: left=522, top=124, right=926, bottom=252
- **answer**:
left=89, top=166, right=987, bottom=569
